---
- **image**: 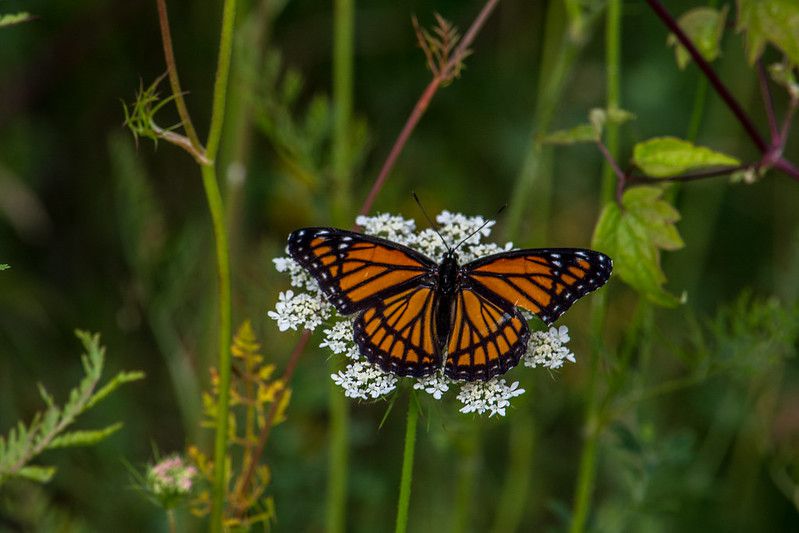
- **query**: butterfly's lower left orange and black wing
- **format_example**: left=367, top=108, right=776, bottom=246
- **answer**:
left=355, top=285, right=441, bottom=377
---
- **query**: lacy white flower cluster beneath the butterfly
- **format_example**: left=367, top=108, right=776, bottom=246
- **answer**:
left=268, top=211, right=574, bottom=416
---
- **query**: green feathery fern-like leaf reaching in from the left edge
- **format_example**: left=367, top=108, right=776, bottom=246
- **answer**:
left=0, top=331, right=144, bottom=485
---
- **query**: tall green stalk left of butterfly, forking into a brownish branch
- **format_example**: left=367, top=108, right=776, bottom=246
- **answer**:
left=202, top=0, right=236, bottom=532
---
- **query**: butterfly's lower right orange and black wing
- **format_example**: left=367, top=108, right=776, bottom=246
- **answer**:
left=444, top=288, right=530, bottom=381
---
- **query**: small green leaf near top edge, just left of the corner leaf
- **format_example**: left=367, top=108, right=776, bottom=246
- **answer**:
left=666, top=5, right=728, bottom=69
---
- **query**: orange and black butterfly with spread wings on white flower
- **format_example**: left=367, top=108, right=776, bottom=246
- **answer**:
left=288, top=227, right=613, bottom=381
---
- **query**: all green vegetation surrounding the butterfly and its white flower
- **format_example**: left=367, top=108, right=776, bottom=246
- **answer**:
left=0, top=0, right=799, bottom=532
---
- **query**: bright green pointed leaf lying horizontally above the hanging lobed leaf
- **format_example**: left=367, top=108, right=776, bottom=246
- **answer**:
left=633, top=137, right=741, bottom=178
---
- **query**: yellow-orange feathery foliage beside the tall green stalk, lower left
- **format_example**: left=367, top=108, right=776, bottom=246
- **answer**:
left=188, top=321, right=291, bottom=529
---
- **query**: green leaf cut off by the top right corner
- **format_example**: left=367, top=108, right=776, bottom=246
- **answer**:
left=737, top=0, right=799, bottom=64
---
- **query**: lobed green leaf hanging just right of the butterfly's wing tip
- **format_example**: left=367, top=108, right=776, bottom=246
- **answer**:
left=593, top=187, right=684, bottom=307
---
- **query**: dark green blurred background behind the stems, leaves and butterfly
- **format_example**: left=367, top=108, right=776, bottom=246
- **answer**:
left=0, top=0, right=799, bottom=531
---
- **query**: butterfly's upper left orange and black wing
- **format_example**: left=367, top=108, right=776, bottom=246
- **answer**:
left=288, top=228, right=436, bottom=315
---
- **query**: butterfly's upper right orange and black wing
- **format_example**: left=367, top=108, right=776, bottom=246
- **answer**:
left=463, top=248, right=613, bottom=324
